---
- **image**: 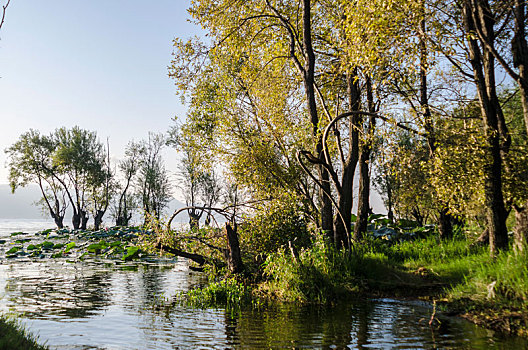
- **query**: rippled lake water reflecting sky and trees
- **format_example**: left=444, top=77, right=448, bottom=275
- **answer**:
left=0, top=220, right=528, bottom=349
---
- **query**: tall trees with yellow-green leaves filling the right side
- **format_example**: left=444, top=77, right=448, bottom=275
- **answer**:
left=170, top=0, right=528, bottom=253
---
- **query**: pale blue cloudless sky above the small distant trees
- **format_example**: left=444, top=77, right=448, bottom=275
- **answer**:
left=0, top=0, right=200, bottom=184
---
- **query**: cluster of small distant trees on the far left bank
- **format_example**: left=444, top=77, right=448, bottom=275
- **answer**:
left=6, top=127, right=171, bottom=230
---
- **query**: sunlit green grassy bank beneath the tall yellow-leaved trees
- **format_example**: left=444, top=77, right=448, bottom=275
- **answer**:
left=178, top=235, right=528, bottom=335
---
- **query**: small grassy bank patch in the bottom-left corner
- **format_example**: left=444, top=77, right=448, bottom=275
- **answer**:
left=0, top=317, right=47, bottom=350
